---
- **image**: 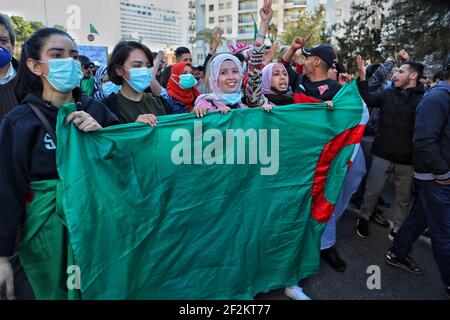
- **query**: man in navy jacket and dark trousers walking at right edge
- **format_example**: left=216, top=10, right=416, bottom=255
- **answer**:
left=386, top=53, right=450, bottom=298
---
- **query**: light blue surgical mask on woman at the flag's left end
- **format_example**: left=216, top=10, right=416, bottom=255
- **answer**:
left=40, top=58, right=83, bottom=93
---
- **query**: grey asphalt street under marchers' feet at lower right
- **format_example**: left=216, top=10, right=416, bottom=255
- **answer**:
left=256, top=180, right=446, bottom=300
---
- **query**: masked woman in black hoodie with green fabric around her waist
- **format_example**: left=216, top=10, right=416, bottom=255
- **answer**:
left=0, top=28, right=119, bottom=299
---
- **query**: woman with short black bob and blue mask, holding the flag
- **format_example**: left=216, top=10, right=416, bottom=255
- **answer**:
left=102, top=41, right=167, bottom=126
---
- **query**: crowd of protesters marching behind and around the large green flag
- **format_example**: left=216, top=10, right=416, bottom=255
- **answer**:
left=0, top=0, right=450, bottom=300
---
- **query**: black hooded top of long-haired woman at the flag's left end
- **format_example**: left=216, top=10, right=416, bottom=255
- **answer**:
left=0, top=94, right=119, bottom=257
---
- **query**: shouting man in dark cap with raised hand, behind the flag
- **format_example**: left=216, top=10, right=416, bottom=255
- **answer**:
left=280, top=37, right=341, bottom=103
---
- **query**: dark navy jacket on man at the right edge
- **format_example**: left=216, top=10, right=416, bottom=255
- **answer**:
left=414, top=81, right=450, bottom=180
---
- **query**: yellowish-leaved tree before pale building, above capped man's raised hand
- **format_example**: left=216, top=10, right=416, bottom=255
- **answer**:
left=280, top=5, right=328, bottom=46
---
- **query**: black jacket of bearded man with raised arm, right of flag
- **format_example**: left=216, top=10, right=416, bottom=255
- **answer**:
left=358, top=80, right=424, bottom=165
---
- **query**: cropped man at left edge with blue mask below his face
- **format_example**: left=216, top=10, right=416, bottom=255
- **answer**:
left=0, top=14, right=19, bottom=118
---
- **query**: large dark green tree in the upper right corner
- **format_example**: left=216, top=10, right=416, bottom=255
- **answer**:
left=334, top=0, right=450, bottom=64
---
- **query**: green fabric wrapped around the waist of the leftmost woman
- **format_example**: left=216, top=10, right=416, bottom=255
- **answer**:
left=19, top=180, right=80, bottom=300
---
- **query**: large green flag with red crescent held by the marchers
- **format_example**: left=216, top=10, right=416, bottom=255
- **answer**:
left=57, top=83, right=364, bottom=299
